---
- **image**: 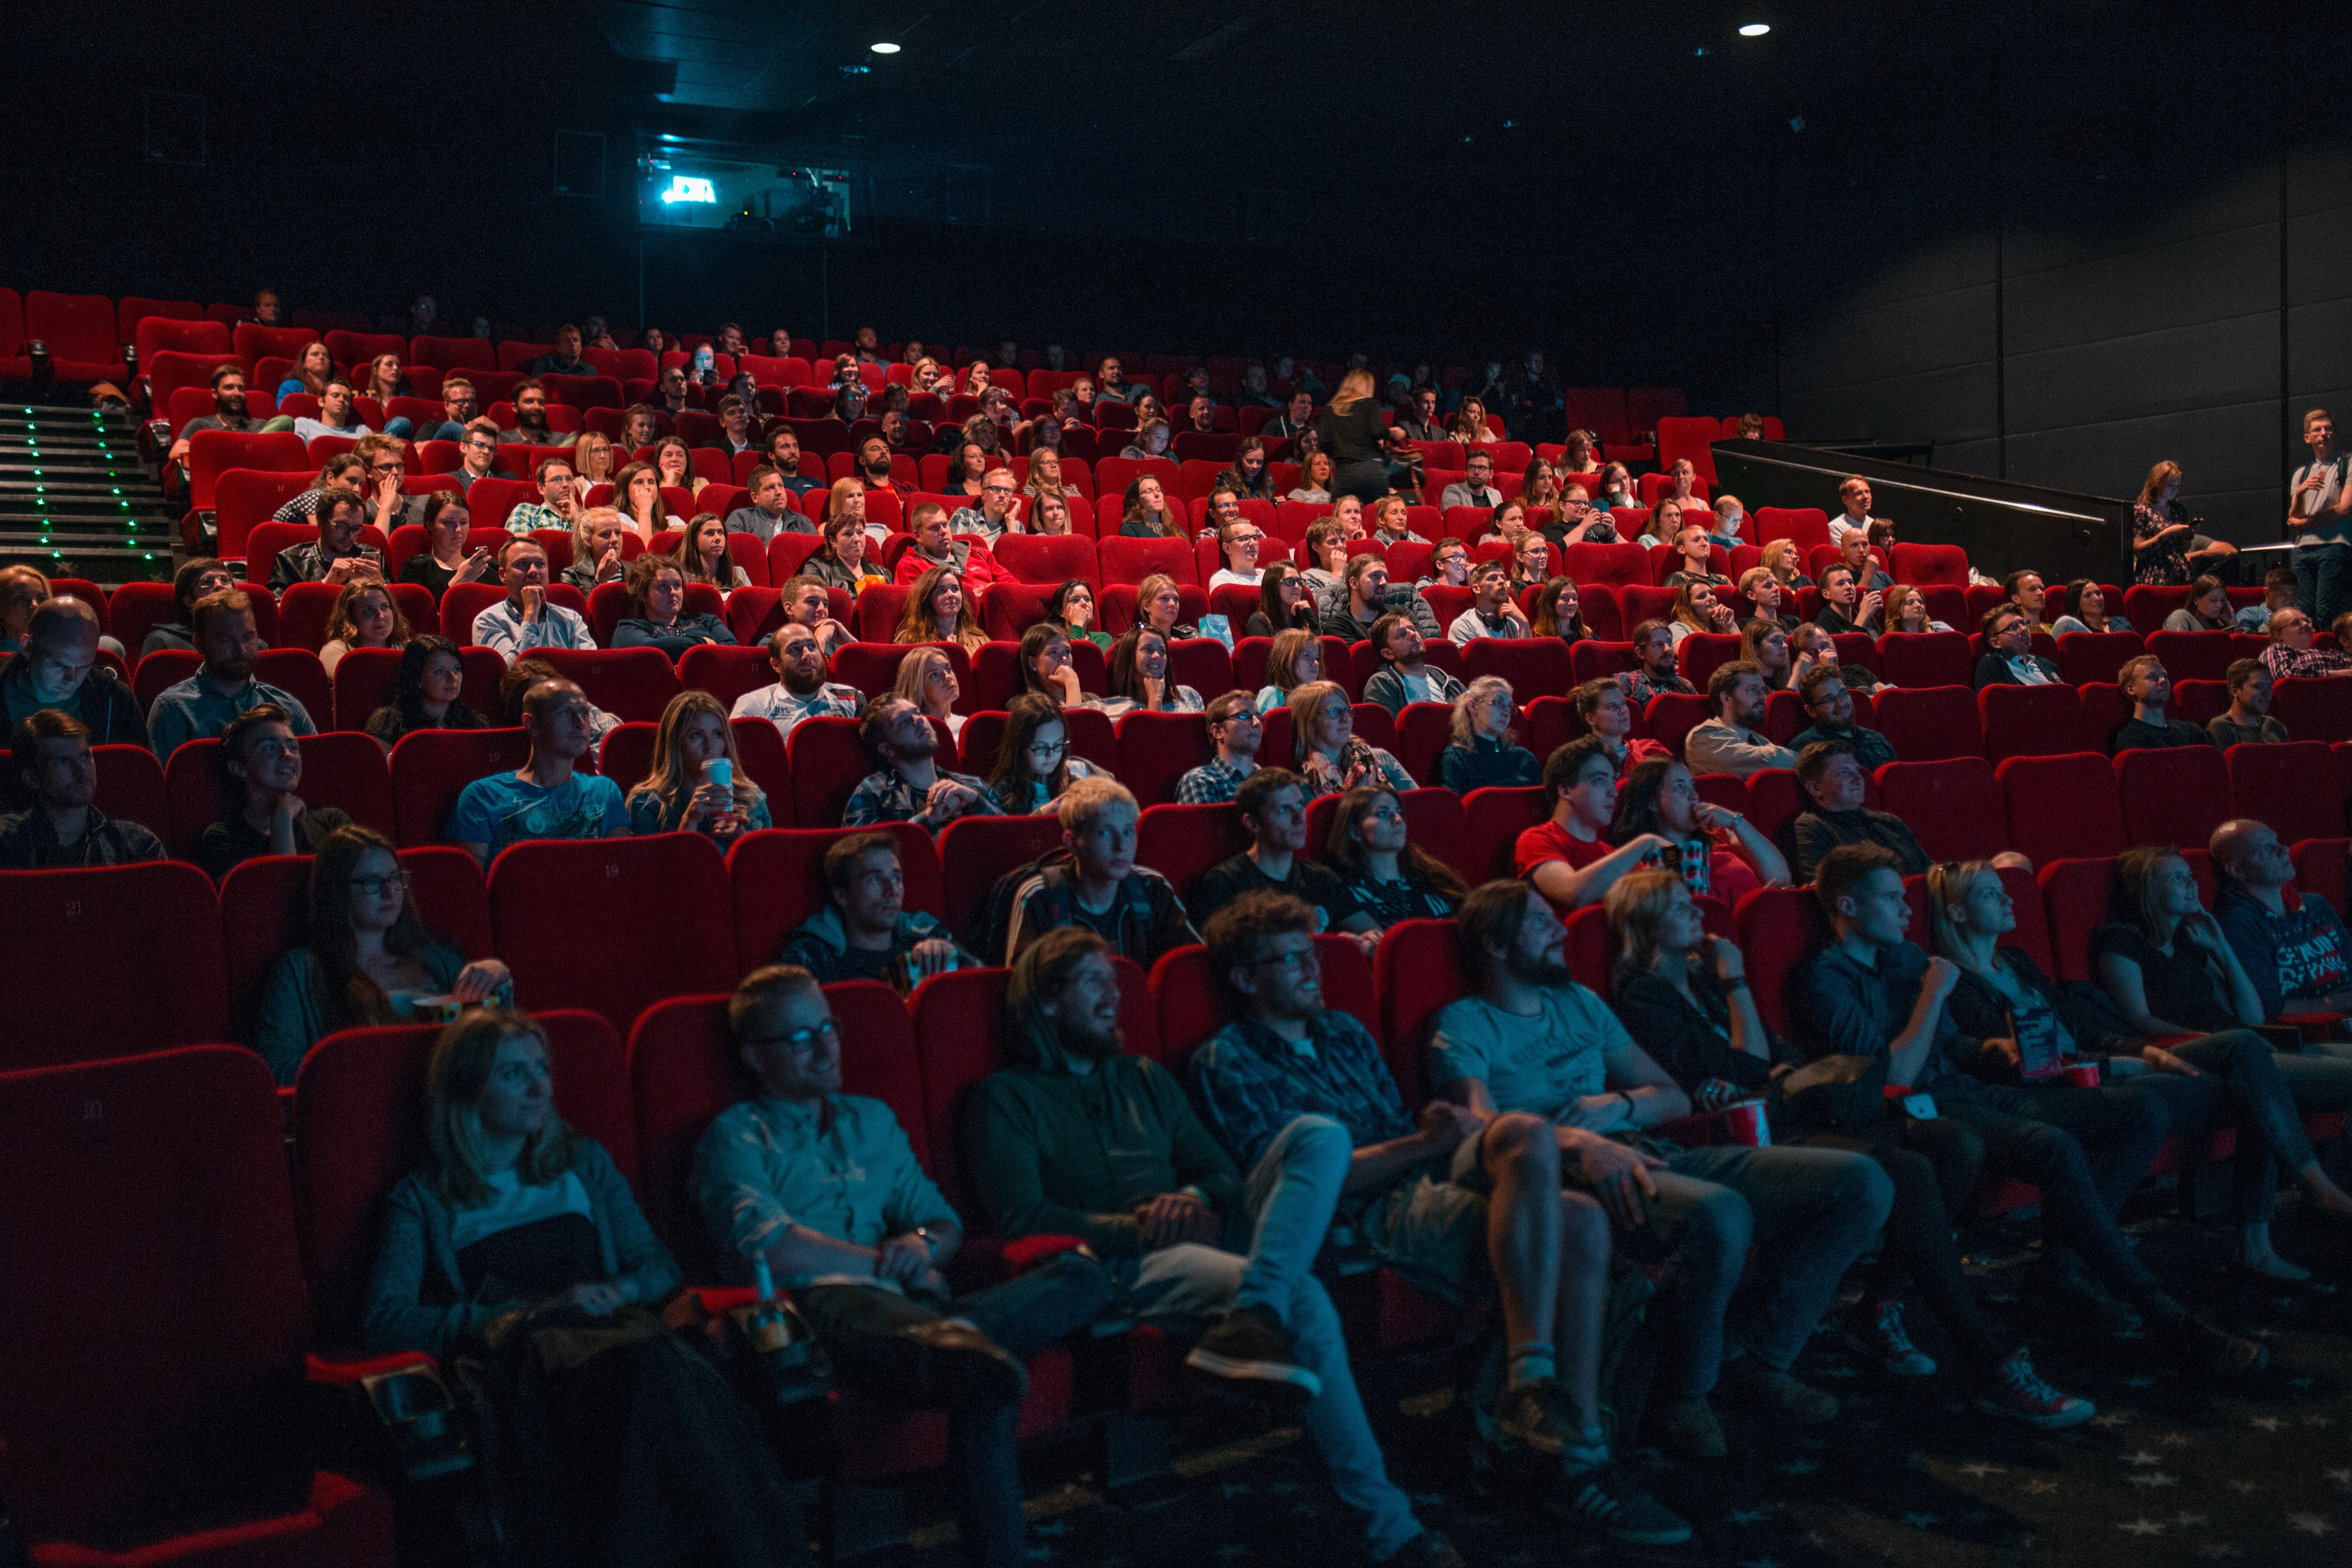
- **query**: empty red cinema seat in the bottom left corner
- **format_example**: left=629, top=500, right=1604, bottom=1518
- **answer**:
left=0, top=1046, right=393, bottom=1568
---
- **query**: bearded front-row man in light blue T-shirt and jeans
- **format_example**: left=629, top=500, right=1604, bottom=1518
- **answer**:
left=1428, top=882, right=1893, bottom=1458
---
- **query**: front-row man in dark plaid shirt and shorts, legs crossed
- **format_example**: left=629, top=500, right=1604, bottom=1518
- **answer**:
left=1192, top=893, right=1691, bottom=1544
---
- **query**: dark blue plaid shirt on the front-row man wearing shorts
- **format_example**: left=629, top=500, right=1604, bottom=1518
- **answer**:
left=1192, top=1008, right=1416, bottom=1220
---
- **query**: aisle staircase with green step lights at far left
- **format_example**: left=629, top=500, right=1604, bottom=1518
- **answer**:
left=0, top=402, right=174, bottom=588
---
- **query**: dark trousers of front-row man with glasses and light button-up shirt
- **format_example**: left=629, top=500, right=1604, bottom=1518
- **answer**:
left=793, top=1253, right=1110, bottom=1568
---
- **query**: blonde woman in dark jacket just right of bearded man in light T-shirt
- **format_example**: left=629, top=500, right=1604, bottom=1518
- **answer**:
left=1604, top=870, right=2096, bottom=1429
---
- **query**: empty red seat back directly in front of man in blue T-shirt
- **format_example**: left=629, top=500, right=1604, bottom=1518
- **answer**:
left=489, top=832, right=736, bottom=1030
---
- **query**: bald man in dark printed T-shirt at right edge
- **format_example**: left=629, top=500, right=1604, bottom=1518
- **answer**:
left=2206, top=818, right=2352, bottom=1020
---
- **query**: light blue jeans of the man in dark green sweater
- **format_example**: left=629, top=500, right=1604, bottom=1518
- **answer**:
left=1122, top=1117, right=1421, bottom=1556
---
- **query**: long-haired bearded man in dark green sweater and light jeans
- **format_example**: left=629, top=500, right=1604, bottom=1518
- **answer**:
left=962, top=926, right=1463, bottom=1568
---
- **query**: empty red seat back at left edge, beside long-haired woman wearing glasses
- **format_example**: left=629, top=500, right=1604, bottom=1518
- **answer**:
left=0, top=861, right=228, bottom=1072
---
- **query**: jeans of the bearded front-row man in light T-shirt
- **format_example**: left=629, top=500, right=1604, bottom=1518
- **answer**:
left=1623, top=1142, right=1893, bottom=1399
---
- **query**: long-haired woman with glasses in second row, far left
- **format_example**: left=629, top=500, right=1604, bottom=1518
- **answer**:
left=252, top=827, right=513, bottom=1084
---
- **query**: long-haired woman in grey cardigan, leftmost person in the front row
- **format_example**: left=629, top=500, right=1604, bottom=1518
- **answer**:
left=362, top=1008, right=809, bottom=1568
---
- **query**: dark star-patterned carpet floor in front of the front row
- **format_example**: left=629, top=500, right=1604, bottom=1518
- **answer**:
left=896, top=1197, right=2352, bottom=1568
